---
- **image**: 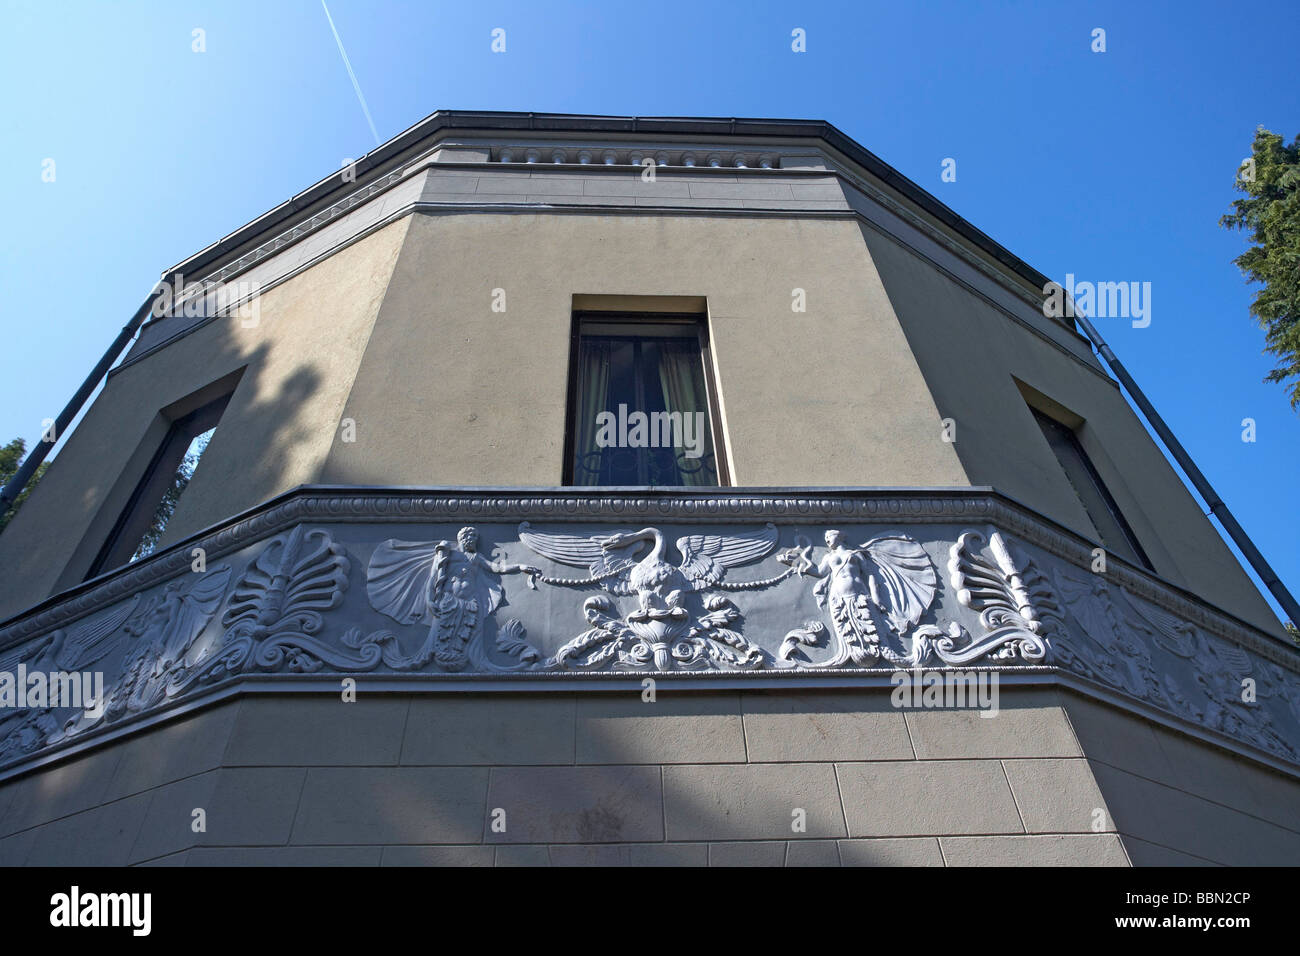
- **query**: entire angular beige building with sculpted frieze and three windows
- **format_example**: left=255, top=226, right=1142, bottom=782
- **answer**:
left=0, top=112, right=1300, bottom=865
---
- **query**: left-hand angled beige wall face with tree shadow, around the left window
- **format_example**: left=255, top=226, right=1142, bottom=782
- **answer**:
left=0, top=220, right=408, bottom=618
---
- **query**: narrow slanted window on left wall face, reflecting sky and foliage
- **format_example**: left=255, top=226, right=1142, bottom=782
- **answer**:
left=86, top=393, right=230, bottom=578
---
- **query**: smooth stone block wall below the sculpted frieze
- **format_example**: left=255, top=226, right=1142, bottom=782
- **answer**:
left=0, top=688, right=1300, bottom=866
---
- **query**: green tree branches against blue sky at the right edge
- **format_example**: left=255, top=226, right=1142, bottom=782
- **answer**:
left=1219, top=126, right=1300, bottom=408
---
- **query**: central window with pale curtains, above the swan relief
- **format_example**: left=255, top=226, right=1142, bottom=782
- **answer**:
left=564, top=313, right=727, bottom=486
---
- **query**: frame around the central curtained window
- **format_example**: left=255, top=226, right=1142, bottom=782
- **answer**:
left=562, top=310, right=732, bottom=490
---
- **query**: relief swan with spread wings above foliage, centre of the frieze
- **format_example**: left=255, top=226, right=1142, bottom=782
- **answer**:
left=519, top=522, right=790, bottom=671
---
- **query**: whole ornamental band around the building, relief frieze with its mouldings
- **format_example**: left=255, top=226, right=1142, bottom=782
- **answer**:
left=0, top=486, right=1300, bottom=777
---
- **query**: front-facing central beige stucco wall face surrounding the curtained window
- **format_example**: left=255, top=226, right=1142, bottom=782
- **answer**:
left=324, top=213, right=966, bottom=485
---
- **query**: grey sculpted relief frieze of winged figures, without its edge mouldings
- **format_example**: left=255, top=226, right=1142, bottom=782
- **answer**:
left=0, top=501, right=1300, bottom=766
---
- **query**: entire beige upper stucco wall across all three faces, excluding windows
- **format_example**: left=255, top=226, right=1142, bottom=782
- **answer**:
left=0, top=195, right=1279, bottom=632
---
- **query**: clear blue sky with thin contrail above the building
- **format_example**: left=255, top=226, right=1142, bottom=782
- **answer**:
left=0, top=0, right=1300, bottom=621
